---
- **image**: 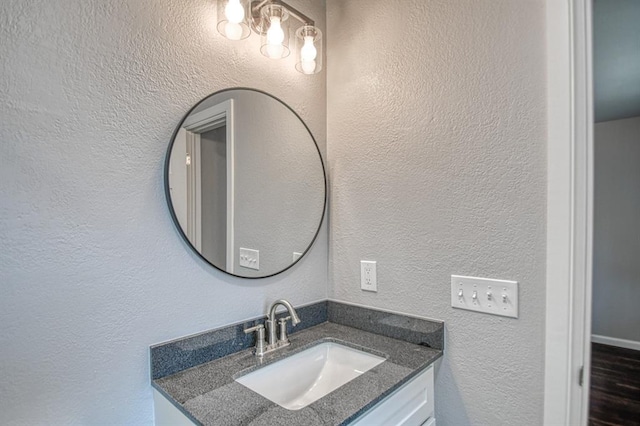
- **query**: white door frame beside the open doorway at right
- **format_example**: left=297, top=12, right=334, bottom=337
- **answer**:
left=544, top=0, right=593, bottom=425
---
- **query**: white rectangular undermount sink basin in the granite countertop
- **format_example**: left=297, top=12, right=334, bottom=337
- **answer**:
left=236, top=342, right=385, bottom=410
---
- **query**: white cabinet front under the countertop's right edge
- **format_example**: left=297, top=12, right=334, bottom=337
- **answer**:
left=351, top=365, right=436, bottom=426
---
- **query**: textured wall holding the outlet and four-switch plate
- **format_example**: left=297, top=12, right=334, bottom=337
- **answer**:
left=327, top=0, right=546, bottom=426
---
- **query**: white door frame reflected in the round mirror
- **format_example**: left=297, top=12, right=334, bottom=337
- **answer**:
left=182, top=99, right=235, bottom=273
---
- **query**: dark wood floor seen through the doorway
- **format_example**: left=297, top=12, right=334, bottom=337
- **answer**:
left=589, top=343, right=640, bottom=426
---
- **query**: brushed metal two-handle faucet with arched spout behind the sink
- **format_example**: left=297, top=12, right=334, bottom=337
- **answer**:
left=244, top=299, right=300, bottom=357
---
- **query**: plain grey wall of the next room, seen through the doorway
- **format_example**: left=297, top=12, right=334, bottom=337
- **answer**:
left=592, top=117, right=640, bottom=343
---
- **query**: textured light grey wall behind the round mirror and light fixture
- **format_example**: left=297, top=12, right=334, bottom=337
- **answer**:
left=0, top=0, right=327, bottom=425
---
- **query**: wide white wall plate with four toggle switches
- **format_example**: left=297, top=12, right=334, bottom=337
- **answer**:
left=451, top=275, right=518, bottom=318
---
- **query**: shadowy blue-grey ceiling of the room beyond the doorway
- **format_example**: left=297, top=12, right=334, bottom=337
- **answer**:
left=593, top=0, right=640, bottom=122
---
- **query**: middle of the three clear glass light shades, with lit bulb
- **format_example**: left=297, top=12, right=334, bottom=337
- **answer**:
left=260, top=4, right=290, bottom=59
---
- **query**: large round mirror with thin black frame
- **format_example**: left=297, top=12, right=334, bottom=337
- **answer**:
left=165, top=88, right=326, bottom=278
